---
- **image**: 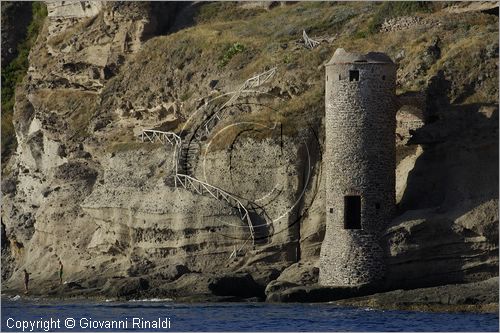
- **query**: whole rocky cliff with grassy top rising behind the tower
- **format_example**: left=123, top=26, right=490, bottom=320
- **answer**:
left=2, top=1, right=498, bottom=304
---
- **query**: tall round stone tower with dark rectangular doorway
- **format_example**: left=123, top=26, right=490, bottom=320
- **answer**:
left=319, top=49, right=397, bottom=286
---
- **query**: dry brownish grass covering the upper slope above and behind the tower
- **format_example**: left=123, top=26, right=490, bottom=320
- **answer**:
left=103, top=2, right=498, bottom=149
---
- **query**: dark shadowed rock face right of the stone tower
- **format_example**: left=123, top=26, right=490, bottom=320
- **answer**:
left=384, top=100, right=498, bottom=288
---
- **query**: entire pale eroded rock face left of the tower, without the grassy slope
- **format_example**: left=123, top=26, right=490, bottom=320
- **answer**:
left=2, top=2, right=321, bottom=297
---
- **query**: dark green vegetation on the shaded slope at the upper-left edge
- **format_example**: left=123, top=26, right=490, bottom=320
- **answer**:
left=2, top=1, right=47, bottom=162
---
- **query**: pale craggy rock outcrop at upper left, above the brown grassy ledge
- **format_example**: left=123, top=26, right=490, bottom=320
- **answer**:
left=29, top=1, right=183, bottom=92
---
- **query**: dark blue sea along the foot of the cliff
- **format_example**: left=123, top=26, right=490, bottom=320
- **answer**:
left=1, top=298, right=498, bottom=332
